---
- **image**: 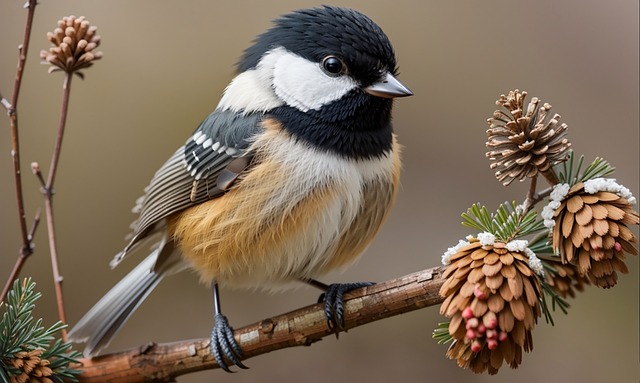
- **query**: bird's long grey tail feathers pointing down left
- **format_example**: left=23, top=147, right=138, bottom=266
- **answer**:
left=69, top=240, right=184, bottom=357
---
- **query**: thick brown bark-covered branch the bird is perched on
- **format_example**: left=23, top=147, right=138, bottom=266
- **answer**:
left=79, top=267, right=444, bottom=383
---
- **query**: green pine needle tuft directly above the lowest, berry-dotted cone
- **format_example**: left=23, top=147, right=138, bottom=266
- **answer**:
left=462, top=201, right=545, bottom=242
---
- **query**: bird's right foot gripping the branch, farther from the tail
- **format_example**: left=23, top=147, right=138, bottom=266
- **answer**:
left=302, top=279, right=375, bottom=335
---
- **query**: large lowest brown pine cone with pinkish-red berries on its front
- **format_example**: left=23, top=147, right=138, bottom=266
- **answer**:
left=440, top=238, right=542, bottom=374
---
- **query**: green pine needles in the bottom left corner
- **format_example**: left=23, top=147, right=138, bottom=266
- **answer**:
left=0, top=278, right=82, bottom=383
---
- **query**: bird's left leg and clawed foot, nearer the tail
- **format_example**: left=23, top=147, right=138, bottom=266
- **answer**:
left=210, top=282, right=249, bottom=372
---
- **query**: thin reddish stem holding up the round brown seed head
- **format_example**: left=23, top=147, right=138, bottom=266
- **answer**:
left=44, top=72, right=73, bottom=341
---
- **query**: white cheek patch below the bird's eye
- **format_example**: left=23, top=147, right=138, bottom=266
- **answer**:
left=269, top=48, right=358, bottom=112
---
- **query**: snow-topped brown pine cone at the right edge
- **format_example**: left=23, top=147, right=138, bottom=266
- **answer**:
left=552, top=178, right=640, bottom=288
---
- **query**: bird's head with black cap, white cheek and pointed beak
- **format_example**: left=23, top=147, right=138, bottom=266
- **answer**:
left=220, top=6, right=412, bottom=114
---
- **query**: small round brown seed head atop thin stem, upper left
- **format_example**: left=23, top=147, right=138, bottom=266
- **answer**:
left=40, top=16, right=102, bottom=76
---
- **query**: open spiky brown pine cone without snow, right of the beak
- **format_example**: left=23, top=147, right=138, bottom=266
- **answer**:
left=486, top=89, right=571, bottom=186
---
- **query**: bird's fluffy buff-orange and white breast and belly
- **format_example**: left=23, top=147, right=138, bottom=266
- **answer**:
left=168, top=120, right=400, bottom=286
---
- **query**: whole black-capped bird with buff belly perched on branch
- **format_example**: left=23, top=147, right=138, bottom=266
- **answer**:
left=68, top=6, right=413, bottom=372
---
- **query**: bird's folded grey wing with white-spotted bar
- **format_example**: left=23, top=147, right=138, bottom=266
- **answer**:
left=111, top=110, right=264, bottom=267
